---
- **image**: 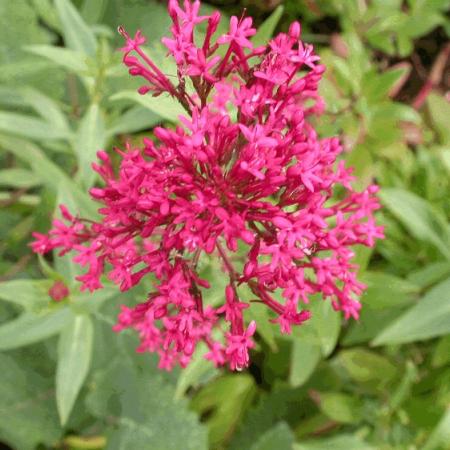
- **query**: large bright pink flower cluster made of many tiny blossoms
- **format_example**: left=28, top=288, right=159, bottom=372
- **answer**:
left=32, top=0, right=383, bottom=370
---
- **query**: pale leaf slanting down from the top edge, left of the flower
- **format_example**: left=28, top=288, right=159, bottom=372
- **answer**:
left=55, top=0, right=97, bottom=56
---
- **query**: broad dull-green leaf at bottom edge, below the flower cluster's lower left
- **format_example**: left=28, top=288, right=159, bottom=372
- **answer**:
left=86, top=358, right=207, bottom=450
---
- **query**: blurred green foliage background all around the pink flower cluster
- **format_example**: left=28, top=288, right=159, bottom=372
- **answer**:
left=0, top=0, right=450, bottom=450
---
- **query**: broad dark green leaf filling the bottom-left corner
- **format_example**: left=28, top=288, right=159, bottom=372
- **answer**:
left=0, top=354, right=61, bottom=450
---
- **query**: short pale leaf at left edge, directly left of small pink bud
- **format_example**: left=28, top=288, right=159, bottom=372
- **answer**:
left=0, top=280, right=53, bottom=310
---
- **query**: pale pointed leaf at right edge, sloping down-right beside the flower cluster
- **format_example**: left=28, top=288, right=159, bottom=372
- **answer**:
left=380, top=188, right=450, bottom=259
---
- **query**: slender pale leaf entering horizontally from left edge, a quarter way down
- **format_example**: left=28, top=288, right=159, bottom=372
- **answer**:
left=0, top=111, right=70, bottom=140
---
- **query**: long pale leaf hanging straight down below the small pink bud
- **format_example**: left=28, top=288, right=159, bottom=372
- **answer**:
left=56, top=314, right=94, bottom=425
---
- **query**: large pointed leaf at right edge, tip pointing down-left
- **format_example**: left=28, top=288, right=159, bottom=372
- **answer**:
left=372, top=278, right=450, bottom=345
